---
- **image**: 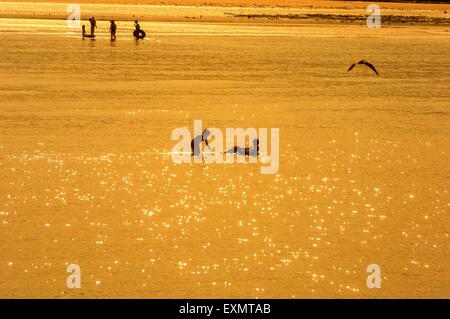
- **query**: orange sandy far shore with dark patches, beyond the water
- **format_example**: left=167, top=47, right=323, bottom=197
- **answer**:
left=0, top=0, right=450, bottom=27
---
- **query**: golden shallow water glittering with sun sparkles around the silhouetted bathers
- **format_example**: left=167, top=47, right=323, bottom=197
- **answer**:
left=0, top=19, right=450, bottom=298
